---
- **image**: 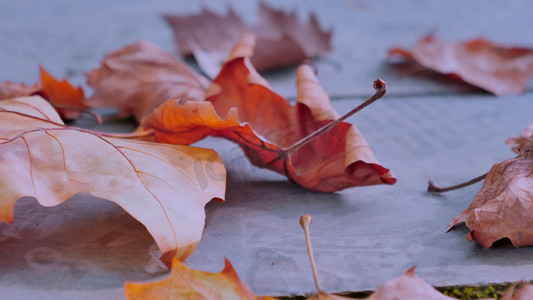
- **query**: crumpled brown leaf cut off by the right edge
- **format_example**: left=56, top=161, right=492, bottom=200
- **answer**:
left=448, top=144, right=533, bottom=248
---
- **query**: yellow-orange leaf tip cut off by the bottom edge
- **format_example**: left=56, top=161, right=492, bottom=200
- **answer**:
left=124, top=255, right=274, bottom=300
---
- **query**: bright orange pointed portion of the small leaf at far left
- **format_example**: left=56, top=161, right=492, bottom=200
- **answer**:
left=39, top=67, right=89, bottom=120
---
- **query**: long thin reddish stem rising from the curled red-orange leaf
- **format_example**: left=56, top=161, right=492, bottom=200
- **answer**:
left=268, top=79, right=387, bottom=164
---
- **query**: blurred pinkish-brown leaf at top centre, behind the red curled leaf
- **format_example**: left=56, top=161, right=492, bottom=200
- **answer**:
left=165, top=3, right=331, bottom=77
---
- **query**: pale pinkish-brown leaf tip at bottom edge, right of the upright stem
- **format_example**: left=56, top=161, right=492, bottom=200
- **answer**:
left=367, top=267, right=454, bottom=300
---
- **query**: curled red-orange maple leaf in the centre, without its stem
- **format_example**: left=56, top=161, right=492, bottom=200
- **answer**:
left=141, top=35, right=396, bottom=192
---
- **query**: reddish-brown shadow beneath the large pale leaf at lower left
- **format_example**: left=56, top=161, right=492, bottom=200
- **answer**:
left=0, top=194, right=168, bottom=290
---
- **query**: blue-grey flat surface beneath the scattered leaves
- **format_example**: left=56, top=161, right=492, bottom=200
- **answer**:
left=0, top=0, right=533, bottom=299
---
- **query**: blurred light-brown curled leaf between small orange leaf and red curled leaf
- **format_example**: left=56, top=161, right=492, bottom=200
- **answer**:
left=87, top=41, right=209, bottom=122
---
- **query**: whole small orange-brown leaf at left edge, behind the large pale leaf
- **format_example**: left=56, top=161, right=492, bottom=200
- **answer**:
left=0, top=67, right=89, bottom=120
